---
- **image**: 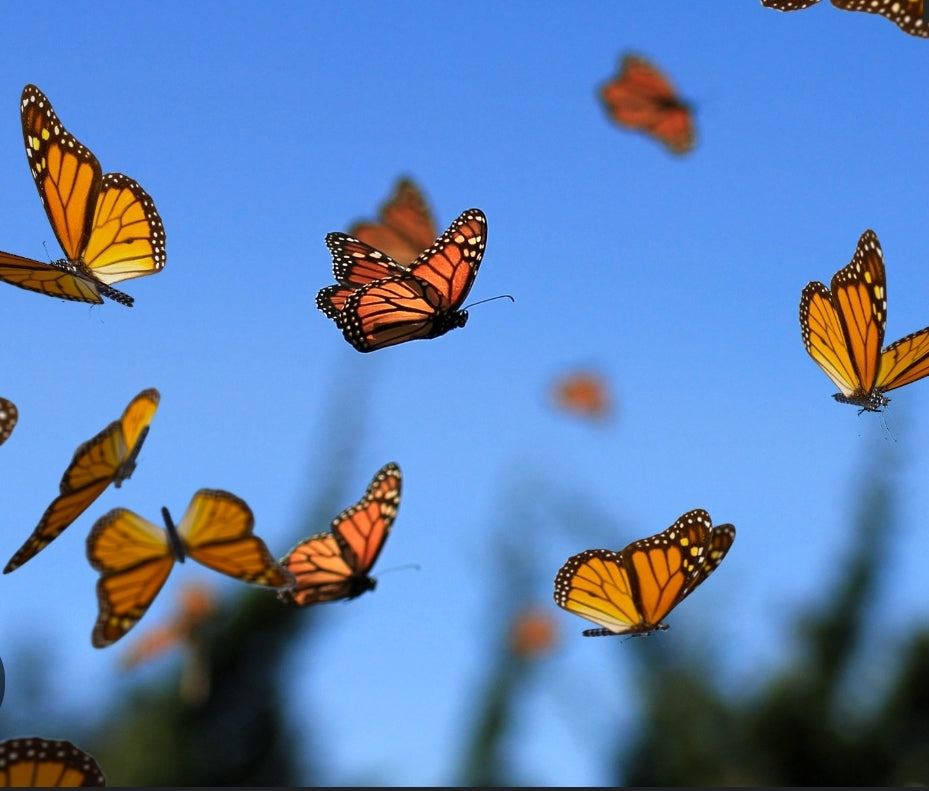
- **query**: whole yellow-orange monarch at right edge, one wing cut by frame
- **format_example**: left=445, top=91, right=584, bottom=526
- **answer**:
left=800, top=230, right=929, bottom=412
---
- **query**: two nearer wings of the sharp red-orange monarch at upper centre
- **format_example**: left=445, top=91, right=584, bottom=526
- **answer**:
left=332, top=209, right=487, bottom=352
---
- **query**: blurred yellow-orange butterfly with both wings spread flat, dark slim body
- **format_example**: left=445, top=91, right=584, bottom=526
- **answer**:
left=87, top=489, right=294, bottom=648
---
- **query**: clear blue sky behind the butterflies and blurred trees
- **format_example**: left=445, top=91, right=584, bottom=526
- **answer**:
left=0, top=0, right=929, bottom=784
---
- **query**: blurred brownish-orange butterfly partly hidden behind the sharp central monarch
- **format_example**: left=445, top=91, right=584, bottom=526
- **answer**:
left=348, top=178, right=439, bottom=266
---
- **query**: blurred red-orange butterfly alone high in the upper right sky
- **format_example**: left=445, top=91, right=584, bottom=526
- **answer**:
left=600, top=55, right=694, bottom=154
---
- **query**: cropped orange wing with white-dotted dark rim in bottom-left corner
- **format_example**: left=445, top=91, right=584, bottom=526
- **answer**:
left=0, top=736, right=106, bottom=788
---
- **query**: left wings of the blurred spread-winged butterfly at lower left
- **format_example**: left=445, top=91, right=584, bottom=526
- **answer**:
left=87, top=508, right=176, bottom=648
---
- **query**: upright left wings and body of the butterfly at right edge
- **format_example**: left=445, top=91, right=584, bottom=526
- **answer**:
left=800, top=230, right=887, bottom=410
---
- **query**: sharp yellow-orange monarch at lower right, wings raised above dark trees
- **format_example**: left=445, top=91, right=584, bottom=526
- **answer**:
left=555, top=508, right=735, bottom=637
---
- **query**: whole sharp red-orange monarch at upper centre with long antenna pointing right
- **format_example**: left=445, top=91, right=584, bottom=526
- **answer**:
left=316, top=209, right=487, bottom=352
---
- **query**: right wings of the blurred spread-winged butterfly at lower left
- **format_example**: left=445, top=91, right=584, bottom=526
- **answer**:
left=169, top=489, right=294, bottom=589
